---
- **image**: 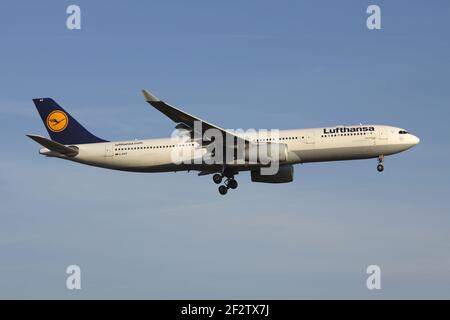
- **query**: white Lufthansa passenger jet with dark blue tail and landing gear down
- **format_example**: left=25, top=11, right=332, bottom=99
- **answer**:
left=27, top=90, right=420, bottom=195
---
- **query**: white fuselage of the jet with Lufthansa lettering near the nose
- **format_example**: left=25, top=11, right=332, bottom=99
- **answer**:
left=40, top=125, right=419, bottom=172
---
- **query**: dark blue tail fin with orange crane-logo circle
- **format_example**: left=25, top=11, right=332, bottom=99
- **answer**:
left=33, top=98, right=106, bottom=144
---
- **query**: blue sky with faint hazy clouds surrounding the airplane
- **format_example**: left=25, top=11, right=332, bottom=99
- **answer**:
left=0, top=0, right=450, bottom=299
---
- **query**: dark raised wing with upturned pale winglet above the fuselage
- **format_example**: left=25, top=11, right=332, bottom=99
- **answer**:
left=142, top=90, right=249, bottom=142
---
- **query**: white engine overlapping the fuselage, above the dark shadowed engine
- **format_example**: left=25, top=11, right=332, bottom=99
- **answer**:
left=245, top=143, right=288, bottom=164
